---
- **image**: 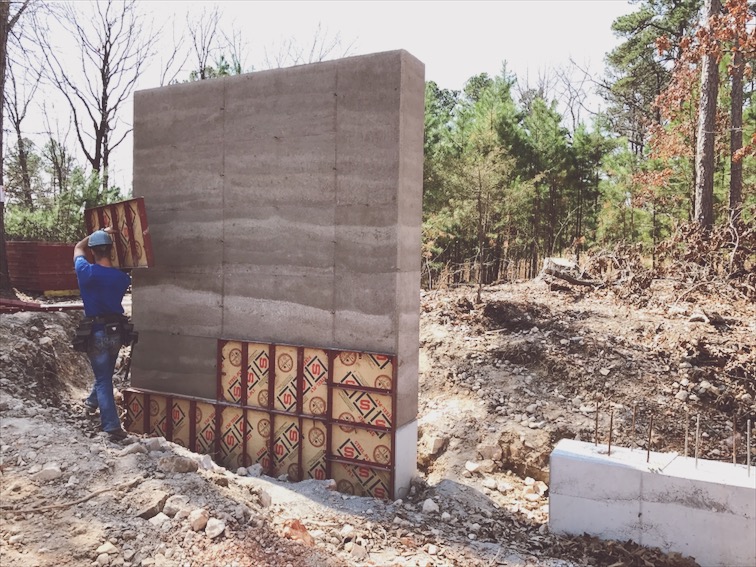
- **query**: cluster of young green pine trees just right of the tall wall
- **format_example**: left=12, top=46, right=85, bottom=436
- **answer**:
left=423, top=67, right=613, bottom=284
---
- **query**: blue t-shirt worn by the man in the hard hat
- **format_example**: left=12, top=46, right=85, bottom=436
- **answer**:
left=74, top=256, right=131, bottom=317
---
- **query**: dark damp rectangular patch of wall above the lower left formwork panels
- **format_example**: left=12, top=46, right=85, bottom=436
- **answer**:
left=131, top=330, right=218, bottom=399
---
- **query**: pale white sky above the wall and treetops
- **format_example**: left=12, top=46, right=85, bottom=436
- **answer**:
left=16, top=0, right=633, bottom=195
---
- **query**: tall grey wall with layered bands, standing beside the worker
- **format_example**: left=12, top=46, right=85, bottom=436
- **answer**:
left=132, top=51, right=425, bottom=498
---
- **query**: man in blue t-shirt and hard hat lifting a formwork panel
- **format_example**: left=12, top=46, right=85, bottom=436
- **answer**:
left=73, top=227, right=131, bottom=441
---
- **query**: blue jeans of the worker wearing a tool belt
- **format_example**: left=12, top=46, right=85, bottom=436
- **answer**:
left=87, top=329, right=121, bottom=431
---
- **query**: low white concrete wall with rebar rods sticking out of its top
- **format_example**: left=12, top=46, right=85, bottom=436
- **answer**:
left=549, top=439, right=756, bottom=567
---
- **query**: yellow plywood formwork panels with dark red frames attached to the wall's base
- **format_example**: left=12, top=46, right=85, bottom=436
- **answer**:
left=125, top=340, right=396, bottom=498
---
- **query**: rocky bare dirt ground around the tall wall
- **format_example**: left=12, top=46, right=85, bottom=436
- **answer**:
left=0, top=274, right=756, bottom=567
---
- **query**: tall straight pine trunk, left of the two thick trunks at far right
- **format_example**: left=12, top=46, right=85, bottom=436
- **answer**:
left=694, top=0, right=720, bottom=230
